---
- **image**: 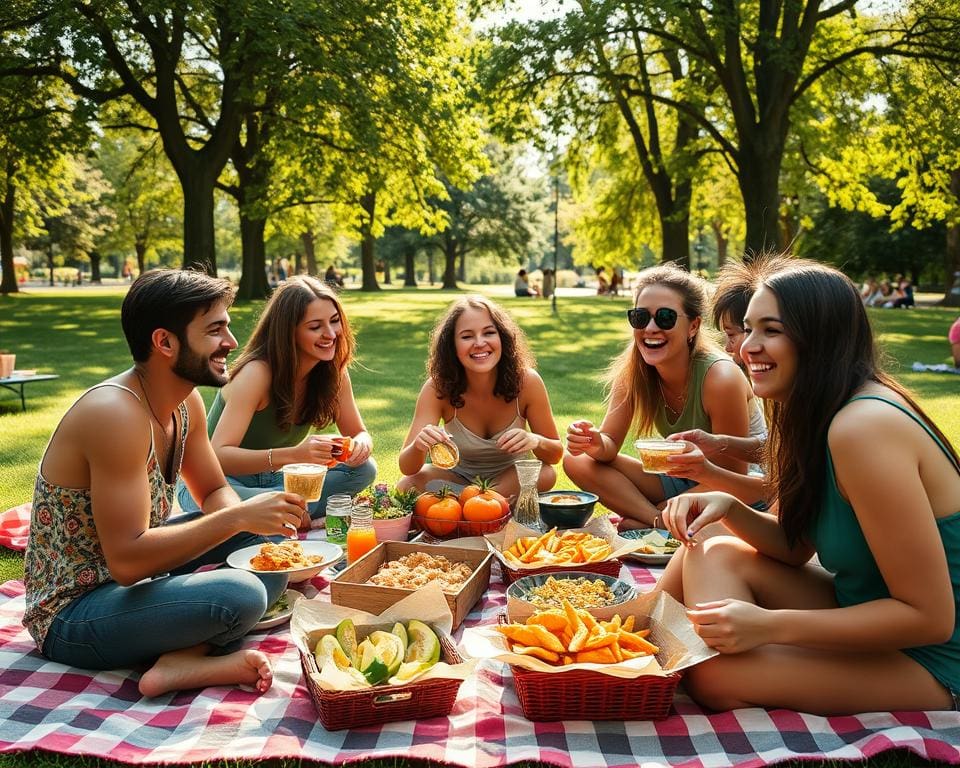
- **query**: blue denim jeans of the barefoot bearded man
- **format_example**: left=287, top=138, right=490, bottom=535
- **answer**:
left=43, top=515, right=287, bottom=669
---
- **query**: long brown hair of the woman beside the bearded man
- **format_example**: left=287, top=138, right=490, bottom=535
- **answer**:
left=230, top=275, right=356, bottom=430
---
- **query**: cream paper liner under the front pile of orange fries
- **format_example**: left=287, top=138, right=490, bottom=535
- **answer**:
left=461, top=592, right=717, bottom=678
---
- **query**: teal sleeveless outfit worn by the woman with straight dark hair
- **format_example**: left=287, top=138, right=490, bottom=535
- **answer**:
left=811, top=395, right=960, bottom=693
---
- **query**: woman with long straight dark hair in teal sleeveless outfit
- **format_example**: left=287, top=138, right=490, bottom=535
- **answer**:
left=661, top=260, right=960, bottom=715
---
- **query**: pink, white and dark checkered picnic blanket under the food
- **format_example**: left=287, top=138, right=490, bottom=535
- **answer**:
left=0, top=566, right=960, bottom=768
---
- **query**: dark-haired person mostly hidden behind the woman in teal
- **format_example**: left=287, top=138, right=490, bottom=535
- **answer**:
left=667, top=256, right=790, bottom=508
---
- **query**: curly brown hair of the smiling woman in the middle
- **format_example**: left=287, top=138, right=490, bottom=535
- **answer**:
left=427, top=296, right=534, bottom=408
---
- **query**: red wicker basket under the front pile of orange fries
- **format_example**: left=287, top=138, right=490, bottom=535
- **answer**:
left=510, top=664, right=682, bottom=720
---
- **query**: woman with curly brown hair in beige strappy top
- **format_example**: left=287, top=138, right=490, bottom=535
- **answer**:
left=398, top=296, right=563, bottom=497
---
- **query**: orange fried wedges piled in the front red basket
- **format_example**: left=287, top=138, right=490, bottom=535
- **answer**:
left=496, top=600, right=660, bottom=666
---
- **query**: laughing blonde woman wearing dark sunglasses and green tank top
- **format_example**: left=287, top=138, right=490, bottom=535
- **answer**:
left=563, top=264, right=753, bottom=529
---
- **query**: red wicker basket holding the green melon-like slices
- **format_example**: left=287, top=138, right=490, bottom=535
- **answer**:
left=300, top=634, right=463, bottom=731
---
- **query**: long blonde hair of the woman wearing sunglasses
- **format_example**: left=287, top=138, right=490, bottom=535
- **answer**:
left=604, top=263, right=720, bottom=435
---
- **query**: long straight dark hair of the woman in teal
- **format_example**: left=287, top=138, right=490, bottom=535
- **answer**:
left=754, top=259, right=957, bottom=543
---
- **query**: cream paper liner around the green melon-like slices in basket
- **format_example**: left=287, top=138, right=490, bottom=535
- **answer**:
left=290, top=581, right=477, bottom=691
